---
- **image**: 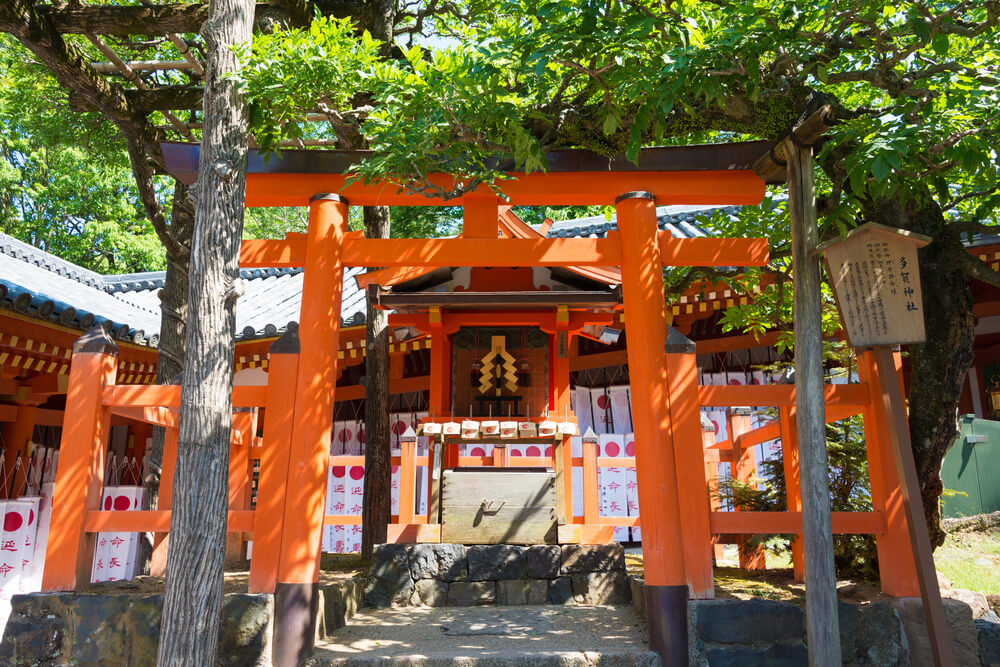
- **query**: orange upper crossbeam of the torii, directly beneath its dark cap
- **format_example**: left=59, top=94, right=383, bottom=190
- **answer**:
left=246, top=170, right=764, bottom=208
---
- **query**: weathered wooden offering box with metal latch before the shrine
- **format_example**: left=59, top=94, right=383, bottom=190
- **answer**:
left=441, top=468, right=556, bottom=544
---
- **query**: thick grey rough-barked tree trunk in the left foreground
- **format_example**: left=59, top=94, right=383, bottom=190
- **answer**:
left=157, top=0, right=254, bottom=667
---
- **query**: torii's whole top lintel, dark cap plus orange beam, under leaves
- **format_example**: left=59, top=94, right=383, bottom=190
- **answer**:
left=162, top=141, right=769, bottom=207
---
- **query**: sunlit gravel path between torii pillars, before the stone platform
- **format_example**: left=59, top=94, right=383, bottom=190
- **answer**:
left=315, top=605, right=648, bottom=659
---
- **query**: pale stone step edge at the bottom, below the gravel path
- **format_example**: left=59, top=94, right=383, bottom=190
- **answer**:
left=306, top=650, right=662, bottom=667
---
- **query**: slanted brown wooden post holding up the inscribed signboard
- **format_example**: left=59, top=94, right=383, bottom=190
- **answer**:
left=875, top=345, right=955, bottom=667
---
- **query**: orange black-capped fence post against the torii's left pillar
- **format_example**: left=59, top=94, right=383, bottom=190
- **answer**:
left=249, top=330, right=299, bottom=593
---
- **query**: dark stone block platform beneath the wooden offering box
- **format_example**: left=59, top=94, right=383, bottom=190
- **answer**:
left=365, top=544, right=632, bottom=607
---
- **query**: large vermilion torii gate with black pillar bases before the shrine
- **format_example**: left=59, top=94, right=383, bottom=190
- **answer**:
left=225, top=145, right=767, bottom=663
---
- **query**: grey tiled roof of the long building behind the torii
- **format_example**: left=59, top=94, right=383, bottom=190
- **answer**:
left=0, top=206, right=720, bottom=347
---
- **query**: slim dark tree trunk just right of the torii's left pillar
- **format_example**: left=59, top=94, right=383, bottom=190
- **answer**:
left=361, top=206, right=392, bottom=560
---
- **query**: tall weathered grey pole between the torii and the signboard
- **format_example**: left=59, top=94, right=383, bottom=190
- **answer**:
left=784, top=138, right=841, bottom=666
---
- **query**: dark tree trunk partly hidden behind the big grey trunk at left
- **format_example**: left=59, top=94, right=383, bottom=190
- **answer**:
left=138, top=181, right=194, bottom=573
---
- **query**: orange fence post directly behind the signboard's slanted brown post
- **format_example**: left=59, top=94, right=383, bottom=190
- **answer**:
left=858, top=350, right=920, bottom=597
